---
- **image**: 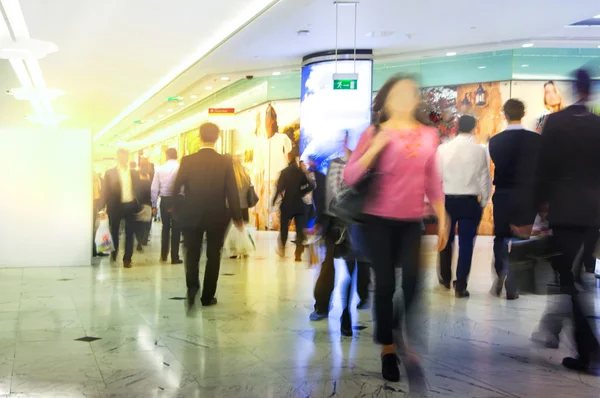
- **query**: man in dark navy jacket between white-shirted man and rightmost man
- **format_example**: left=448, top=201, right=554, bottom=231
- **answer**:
left=489, top=99, right=540, bottom=300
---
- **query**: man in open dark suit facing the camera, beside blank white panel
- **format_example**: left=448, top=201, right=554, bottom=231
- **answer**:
left=102, top=149, right=140, bottom=268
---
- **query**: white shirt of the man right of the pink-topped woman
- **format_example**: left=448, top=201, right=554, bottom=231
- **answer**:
left=438, top=134, right=492, bottom=207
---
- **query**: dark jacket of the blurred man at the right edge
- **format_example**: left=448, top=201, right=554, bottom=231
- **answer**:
left=535, top=105, right=600, bottom=228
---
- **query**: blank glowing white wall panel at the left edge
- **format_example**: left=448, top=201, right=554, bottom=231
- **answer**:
left=0, top=128, right=92, bottom=267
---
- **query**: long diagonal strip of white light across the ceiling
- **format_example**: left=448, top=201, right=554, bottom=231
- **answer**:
left=94, top=0, right=278, bottom=141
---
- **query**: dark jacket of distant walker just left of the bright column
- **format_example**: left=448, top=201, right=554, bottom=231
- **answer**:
left=275, top=162, right=314, bottom=215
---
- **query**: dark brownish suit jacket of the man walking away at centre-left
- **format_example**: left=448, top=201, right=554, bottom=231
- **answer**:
left=173, top=148, right=242, bottom=228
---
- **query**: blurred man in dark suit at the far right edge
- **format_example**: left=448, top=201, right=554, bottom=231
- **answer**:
left=520, top=70, right=600, bottom=371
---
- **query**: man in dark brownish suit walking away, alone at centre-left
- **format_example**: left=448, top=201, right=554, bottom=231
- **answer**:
left=173, top=123, right=244, bottom=306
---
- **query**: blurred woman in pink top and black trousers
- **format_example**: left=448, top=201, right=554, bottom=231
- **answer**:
left=344, top=76, right=448, bottom=381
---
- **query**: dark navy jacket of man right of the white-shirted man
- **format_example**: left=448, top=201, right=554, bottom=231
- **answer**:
left=489, top=129, right=541, bottom=227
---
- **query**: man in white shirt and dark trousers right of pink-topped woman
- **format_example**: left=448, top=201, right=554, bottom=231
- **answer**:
left=438, top=115, right=491, bottom=298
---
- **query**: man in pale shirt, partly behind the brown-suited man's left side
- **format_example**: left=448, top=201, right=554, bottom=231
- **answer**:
left=152, top=148, right=183, bottom=264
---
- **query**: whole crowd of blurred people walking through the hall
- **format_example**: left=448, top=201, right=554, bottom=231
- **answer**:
left=95, top=70, right=600, bottom=381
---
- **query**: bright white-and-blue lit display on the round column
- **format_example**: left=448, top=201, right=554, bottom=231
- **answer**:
left=300, top=60, right=373, bottom=172
